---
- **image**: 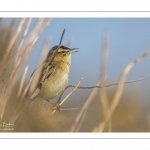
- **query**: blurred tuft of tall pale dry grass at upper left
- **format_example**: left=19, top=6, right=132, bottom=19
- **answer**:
left=0, top=18, right=51, bottom=125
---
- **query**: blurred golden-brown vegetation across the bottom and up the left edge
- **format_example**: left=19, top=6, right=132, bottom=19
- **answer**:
left=0, top=20, right=150, bottom=132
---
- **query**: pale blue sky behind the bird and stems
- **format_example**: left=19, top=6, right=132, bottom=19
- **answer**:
left=3, top=18, right=150, bottom=96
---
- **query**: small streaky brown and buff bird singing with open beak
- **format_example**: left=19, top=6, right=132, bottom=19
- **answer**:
left=27, top=29, right=78, bottom=101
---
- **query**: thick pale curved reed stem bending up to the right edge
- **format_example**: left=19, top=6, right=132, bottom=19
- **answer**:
left=99, top=49, right=150, bottom=132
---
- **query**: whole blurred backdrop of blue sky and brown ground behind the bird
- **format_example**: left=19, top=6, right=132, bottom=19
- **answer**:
left=0, top=18, right=150, bottom=132
